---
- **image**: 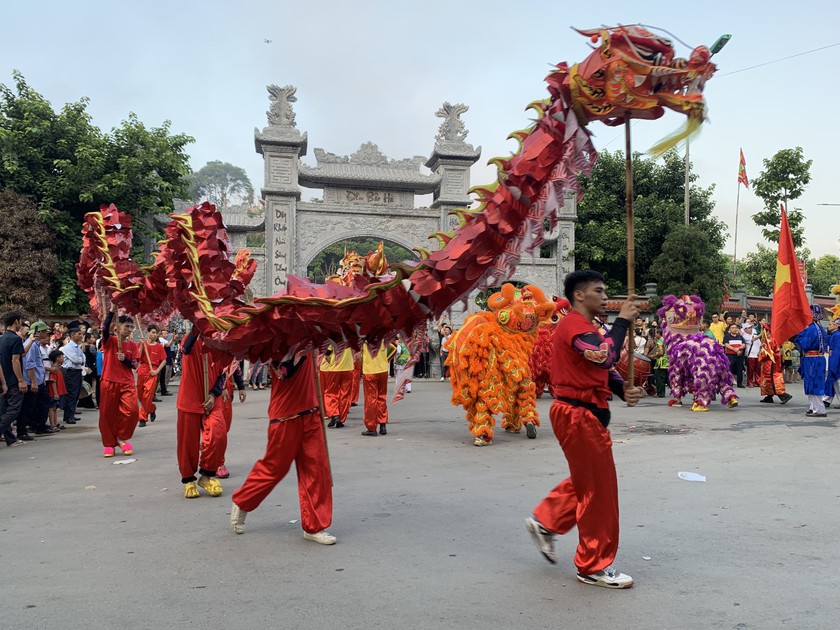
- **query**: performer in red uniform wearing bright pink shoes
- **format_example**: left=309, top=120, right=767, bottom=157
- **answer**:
left=99, top=304, right=139, bottom=457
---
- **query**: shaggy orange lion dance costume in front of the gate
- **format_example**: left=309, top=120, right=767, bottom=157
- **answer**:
left=446, top=284, right=555, bottom=446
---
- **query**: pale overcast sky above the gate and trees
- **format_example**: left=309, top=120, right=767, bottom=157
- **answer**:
left=6, top=0, right=840, bottom=258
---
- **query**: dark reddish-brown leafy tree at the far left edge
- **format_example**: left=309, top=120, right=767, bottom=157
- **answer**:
left=0, top=190, right=58, bottom=317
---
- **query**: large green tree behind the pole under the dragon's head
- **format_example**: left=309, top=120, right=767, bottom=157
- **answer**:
left=575, top=151, right=726, bottom=293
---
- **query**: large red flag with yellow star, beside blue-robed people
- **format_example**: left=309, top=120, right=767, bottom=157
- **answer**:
left=770, top=206, right=812, bottom=344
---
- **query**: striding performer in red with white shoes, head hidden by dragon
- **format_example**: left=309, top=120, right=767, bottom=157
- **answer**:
left=230, top=356, right=335, bottom=545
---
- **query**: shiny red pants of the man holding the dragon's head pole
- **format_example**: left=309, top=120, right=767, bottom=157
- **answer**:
left=534, top=402, right=618, bottom=575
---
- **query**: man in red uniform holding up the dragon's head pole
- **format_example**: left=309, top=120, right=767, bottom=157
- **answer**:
left=526, top=271, right=643, bottom=588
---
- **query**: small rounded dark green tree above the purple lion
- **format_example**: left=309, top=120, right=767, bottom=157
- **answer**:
left=650, top=225, right=729, bottom=310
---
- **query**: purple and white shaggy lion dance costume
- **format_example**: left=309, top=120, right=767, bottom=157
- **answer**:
left=657, top=295, right=738, bottom=411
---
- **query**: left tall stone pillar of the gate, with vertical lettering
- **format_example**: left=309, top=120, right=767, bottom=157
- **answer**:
left=254, top=85, right=307, bottom=295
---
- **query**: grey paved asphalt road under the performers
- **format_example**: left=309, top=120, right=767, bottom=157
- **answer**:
left=0, top=381, right=840, bottom=630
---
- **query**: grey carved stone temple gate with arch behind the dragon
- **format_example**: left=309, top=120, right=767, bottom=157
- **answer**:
left=233, top=85, right=577, bottom=310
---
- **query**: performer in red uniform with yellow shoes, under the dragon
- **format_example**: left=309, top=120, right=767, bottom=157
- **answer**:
left=175, top=327, right=229, bottom=499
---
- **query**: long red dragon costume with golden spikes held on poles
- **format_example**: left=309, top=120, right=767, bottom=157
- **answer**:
left=78, top=26, right=715, bottom=408
